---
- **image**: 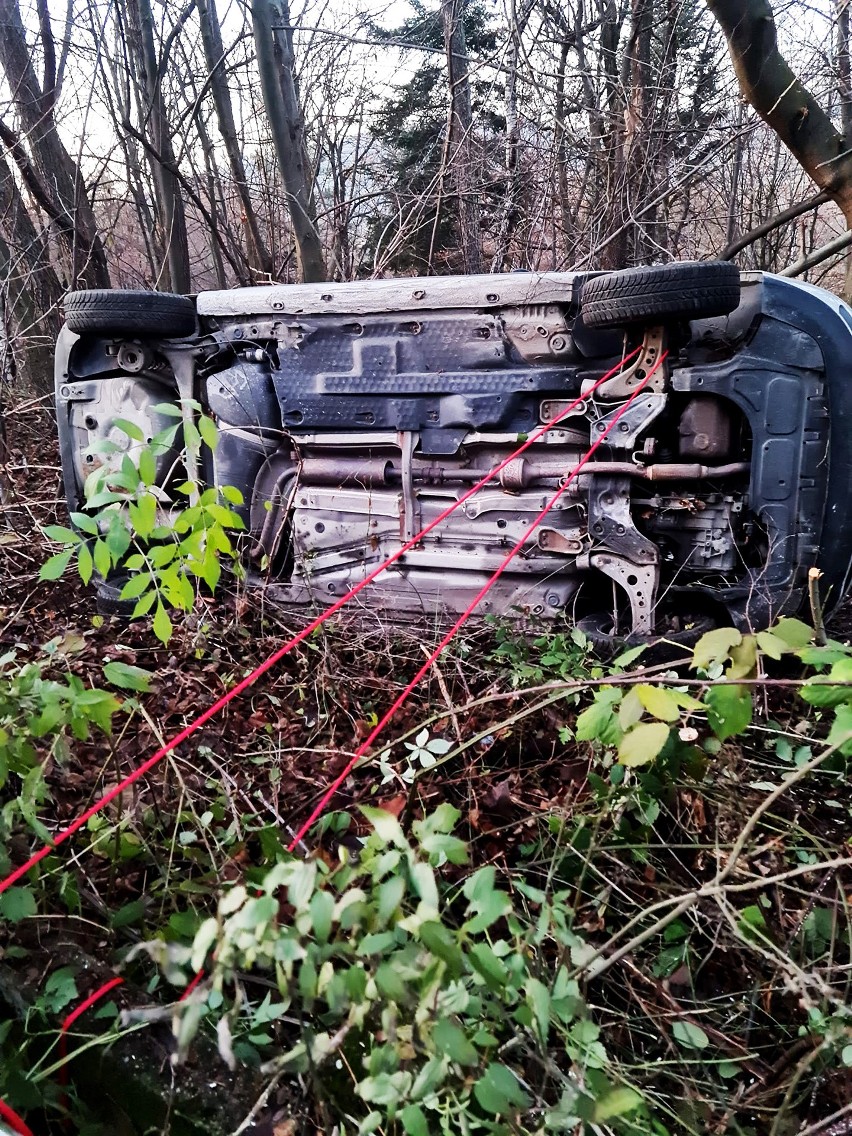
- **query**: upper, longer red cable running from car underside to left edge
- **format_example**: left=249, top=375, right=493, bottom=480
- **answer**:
left=0, top=348, right=640, bottom=895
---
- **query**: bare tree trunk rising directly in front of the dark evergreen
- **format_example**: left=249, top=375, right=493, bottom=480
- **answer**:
left=441, top=0, right=482, bottom=273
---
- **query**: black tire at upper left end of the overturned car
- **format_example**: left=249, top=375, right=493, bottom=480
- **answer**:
left=65, top=289, right=195, bottom=339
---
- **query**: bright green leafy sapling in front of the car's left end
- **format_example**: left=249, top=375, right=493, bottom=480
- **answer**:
left=41, top=400, right=244, bottom=643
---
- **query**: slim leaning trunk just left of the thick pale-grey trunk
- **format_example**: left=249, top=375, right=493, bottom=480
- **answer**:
left=195, top=0, right=273, bottom=277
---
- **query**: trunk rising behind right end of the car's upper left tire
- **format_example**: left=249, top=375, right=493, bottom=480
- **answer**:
left=127, top=0, right=192, bottom=292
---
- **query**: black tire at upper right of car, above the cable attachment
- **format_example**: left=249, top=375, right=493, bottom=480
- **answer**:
left=580, top=260, right=740, bottom=328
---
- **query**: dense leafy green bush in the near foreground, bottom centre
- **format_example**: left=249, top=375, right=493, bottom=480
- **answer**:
left=147, top=804, right=653, bottom=1136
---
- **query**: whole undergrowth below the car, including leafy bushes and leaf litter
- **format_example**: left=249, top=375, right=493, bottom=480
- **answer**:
left=0, top=411, right=852, bottom=1136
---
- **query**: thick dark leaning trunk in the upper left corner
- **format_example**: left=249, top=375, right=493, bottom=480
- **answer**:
left=0, top=0, right=109, bottom=287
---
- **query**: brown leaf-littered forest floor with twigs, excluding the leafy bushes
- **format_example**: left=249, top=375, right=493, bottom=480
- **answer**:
left=0, top=403, right=852, bottom=1136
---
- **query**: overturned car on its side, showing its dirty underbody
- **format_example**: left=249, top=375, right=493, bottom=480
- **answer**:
left=56, top=261, right=852, bottom=638
